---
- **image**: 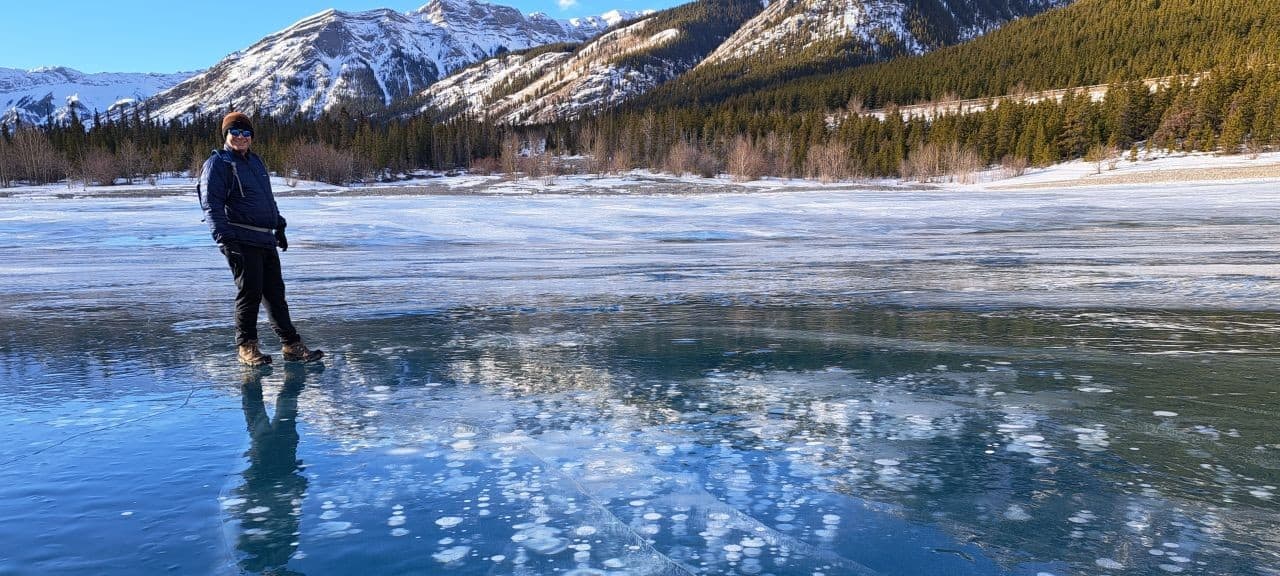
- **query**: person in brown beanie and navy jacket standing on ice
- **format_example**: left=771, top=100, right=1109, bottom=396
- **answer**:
left=196, top=111, right=324, bottom=366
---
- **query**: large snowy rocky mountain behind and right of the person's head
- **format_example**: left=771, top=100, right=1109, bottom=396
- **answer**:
left=151, top=0, right=645, bottom=118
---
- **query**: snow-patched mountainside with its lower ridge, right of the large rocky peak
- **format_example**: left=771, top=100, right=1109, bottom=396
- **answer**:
left=422, top=0, right=1073, bottom=124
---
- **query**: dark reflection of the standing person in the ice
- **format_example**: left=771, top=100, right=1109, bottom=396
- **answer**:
left=236, top=365, right=309, bottom=575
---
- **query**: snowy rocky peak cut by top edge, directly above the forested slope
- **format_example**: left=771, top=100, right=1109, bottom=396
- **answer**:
left=699, top=0, right=1073, bottom=68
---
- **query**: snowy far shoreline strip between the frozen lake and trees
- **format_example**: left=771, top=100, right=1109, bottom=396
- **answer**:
left=0, top=152, right=1280, bottom=200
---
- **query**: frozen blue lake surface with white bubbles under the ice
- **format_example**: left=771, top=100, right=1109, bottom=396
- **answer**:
left=0, top=183, right=1280, bottom=576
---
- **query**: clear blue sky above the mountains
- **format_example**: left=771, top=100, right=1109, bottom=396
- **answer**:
left=0, top=0, right=687, bottom=72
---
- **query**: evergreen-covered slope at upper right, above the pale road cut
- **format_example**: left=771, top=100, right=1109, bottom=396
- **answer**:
left=650, top=0, right=1280, bottom=111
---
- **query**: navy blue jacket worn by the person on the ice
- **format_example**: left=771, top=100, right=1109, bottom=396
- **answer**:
left=197, top=148, right=285, bottom=247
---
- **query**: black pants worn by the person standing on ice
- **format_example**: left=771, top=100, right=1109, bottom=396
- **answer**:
left=219, top=244, right=302, bottom=344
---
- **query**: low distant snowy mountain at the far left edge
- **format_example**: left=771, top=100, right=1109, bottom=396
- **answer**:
left=0, top=68, right=193, bottom=127
